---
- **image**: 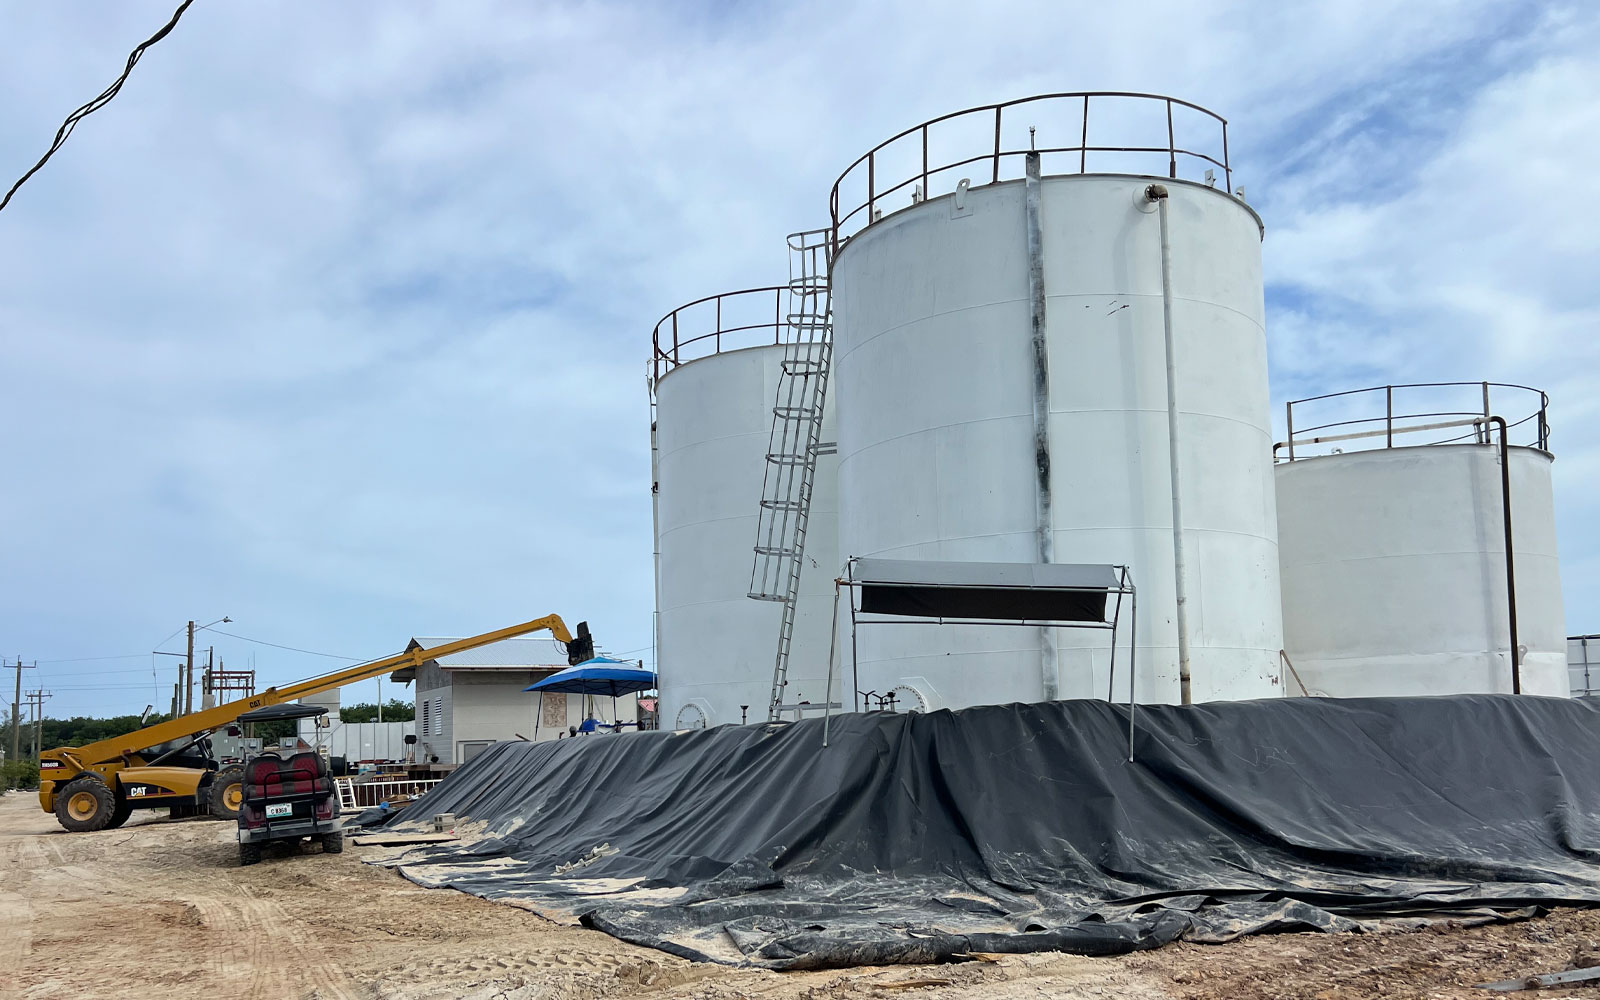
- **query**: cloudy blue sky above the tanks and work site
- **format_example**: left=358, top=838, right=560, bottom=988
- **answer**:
left=0, top=0, right=1600, bottom=715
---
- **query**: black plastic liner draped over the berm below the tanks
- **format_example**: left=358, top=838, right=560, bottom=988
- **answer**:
left=371, top=696, right=1600, bottom=968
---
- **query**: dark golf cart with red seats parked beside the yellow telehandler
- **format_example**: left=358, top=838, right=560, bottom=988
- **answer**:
left=238, top=704, right=344, bottom=864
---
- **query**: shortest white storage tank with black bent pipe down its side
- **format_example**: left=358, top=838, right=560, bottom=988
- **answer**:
left=1277, top=382, right=1568, bottom=698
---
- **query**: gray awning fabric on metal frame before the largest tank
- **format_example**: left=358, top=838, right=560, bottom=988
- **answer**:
left=851, top=558, right=1123, bottom=622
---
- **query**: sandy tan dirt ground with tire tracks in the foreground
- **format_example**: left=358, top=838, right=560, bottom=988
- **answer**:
left=0, top=794, right=1600, bottom=1000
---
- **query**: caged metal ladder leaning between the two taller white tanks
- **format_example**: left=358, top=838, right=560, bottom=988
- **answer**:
left=750, top=229, right=834, bottom=722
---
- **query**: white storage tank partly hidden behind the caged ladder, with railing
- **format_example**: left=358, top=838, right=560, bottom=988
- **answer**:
left=653, top=288, right=838, bottom=730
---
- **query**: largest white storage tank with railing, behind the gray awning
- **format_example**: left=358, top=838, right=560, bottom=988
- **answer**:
left=832, top=94, right=1282, bottom=707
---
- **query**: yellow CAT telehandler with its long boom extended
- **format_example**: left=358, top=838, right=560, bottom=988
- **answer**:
left=38, top=614, right=594, bottom=834
